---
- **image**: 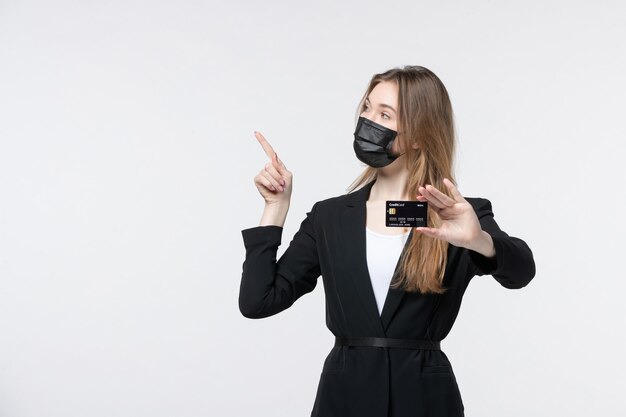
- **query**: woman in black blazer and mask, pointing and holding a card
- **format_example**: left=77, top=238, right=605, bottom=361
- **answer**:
left=239, top=66, right=535, bottom=417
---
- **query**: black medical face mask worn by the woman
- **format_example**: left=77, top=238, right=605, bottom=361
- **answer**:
left=353, top=117, right=400, bottom=168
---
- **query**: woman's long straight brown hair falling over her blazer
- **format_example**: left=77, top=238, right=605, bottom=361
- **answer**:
left=348, top=66, right=456, bottom=294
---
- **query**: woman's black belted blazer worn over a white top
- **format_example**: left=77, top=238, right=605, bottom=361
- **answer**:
left=239, top=182, right=535, bottom=417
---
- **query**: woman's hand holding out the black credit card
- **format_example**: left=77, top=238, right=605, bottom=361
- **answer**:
left=415, top=178, right=493, bottom=255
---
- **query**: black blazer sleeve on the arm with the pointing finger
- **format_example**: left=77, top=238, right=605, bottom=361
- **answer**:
left=239, top=203, right=321, bottom=319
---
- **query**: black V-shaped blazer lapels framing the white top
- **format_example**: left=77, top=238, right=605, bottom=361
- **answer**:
left=341, top=181, right=413, bottom=336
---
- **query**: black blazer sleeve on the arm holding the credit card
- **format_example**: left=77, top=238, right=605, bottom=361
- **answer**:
left=469, top=198, right=535, bottom=289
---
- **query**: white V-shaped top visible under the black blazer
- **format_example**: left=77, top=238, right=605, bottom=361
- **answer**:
left=365, top=227, right=411, bottom=314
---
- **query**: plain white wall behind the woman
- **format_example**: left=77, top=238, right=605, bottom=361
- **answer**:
left=0, top=0, right=626, bottom=417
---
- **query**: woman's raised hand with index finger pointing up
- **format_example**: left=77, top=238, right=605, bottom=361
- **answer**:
left=254, top=132, right=292, bottom=206
